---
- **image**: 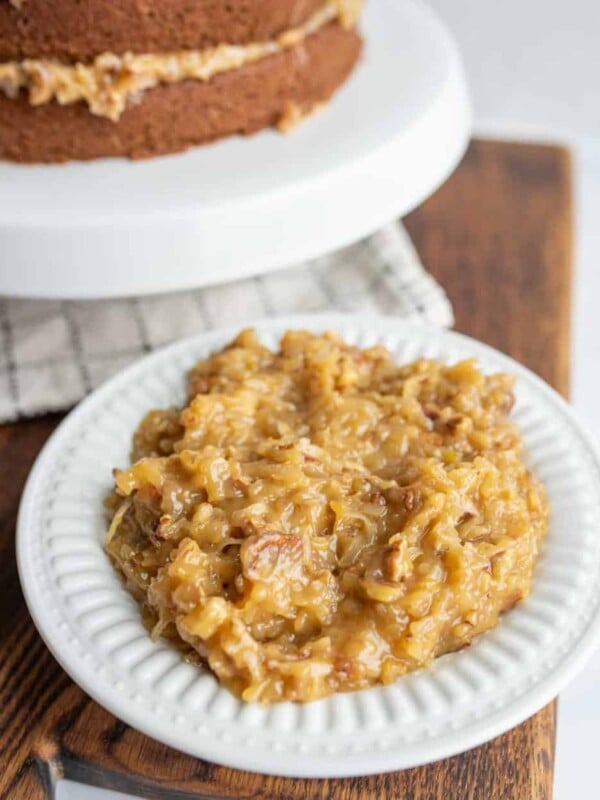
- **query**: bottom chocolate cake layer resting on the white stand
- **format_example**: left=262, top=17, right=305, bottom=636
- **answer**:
left=0, top=23, right=361, bottom=163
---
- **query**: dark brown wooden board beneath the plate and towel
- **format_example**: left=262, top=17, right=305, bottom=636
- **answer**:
left=0, top=142, right=571, bottom=800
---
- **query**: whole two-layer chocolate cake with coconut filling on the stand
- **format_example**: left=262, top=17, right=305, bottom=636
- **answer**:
left=0, top=0, right=362, bottom=162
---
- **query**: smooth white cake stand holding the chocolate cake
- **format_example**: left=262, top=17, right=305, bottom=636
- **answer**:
left=0, top=0, right=471, bottom=298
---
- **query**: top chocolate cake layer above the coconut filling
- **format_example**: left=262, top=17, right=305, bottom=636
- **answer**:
left=0, top=0, right=323, bottom=61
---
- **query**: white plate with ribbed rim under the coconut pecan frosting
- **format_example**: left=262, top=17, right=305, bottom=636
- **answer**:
left=17, top=314, right=600, bottom=777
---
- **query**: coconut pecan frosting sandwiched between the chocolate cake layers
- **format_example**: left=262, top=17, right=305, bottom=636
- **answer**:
left=0, top=0, right=363, bottom=122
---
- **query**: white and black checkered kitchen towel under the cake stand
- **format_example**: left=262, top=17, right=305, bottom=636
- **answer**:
left=0, top=223, right=453, bottom=422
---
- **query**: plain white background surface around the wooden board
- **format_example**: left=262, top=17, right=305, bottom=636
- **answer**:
left=58, top=0, right=600, bottom=800
